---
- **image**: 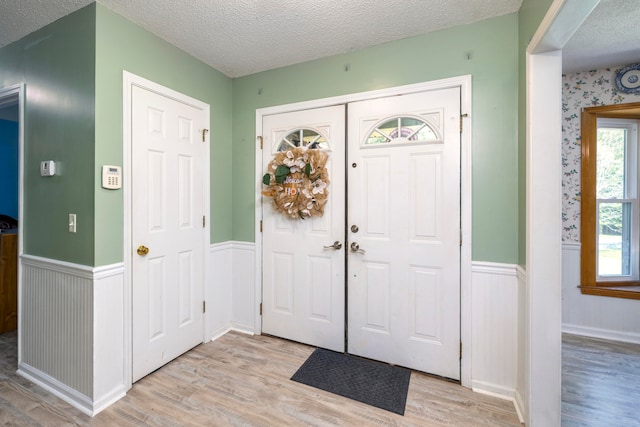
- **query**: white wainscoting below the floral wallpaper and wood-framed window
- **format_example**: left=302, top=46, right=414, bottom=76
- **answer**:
left=562, top=242, right=640, bottom=344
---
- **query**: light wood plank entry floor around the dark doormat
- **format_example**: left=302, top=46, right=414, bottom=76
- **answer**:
left=0, top=332, right=521, bottom=427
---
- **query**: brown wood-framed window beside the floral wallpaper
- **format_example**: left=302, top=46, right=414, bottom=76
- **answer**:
left=581, top=103, right=640, bottom=299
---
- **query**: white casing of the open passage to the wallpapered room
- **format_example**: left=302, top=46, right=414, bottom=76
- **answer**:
left=522, top=0, right=599, bottom=427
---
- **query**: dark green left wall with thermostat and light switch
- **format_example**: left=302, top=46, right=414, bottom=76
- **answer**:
left=0, top=5, right=95, bottom=265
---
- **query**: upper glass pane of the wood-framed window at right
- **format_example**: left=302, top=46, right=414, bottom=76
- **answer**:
left=596, top=127, right=627, bottom=199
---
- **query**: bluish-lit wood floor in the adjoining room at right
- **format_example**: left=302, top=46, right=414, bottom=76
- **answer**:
left=562, top=334, right=640, bottom=427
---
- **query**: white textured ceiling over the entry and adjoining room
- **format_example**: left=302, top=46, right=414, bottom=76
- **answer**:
left=0, top=0, right=640, bottom=77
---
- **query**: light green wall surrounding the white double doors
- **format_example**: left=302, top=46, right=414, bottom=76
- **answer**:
left=233, top=14, right=518, bottom=263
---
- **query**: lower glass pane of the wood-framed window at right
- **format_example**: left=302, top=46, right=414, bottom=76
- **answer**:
left=598, top=202, right=632, bottom=277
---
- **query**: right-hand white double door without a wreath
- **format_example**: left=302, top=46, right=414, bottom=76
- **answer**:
left=347, top=88, right=460, bottom=379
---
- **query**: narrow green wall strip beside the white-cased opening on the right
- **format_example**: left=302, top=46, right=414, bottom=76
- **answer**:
left=518, top=0, right=560, bottom=266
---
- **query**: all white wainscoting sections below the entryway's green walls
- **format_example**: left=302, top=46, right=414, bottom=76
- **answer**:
left=18, top=241, right=526, bottom=415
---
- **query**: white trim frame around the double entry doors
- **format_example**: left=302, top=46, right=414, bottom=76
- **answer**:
left=254, top=74, right=472, bottom=387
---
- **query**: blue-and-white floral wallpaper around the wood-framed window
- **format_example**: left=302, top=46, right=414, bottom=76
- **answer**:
left=562, top=64, right=640, bottom=243
